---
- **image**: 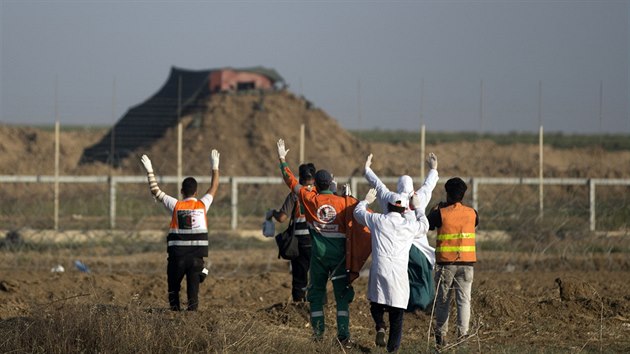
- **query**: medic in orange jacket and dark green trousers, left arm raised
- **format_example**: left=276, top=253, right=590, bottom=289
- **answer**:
left=277, top=139, right=354, bottom=348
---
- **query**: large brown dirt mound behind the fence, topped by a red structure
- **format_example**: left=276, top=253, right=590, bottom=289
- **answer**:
left=116, top=92, right=367, bottom=176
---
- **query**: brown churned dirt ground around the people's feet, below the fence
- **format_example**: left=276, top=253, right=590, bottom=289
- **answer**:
left=0, top=232, right=630, bottom=353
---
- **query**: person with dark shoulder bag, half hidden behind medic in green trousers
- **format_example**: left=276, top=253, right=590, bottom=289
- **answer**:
left=267, top=163, right=316, bottom=302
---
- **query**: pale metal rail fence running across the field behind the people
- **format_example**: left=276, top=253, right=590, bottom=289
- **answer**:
left=0, top=175, right=630, bottom=231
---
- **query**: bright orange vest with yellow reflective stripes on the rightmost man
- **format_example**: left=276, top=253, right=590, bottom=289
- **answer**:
left=435, top=203, right=477, bottom=264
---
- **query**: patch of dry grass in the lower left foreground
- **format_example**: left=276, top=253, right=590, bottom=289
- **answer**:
left=0, top=299, right=336, bottom=353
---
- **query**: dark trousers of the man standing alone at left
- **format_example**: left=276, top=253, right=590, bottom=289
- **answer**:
left=166, top=256, right=203, bottom=311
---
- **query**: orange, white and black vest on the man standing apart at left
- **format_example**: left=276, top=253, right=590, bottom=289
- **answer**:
left=166, top=198, right=208, bottom=257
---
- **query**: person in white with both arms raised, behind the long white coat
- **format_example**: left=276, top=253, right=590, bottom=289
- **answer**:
left=365, top=153, right=440, bottom=312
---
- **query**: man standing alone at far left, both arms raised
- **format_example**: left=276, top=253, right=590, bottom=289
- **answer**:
left=140, top=150, right=219, bottom=311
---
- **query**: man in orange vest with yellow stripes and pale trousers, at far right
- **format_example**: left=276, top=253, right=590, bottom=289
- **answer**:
left=428, top=177, right=479, bottom=347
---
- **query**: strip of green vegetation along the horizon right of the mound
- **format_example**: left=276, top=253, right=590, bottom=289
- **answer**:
left=350, top=129, right=630, bottom=151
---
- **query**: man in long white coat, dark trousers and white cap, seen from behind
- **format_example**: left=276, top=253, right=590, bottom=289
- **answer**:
left=354, top=189, right=429, bottom=352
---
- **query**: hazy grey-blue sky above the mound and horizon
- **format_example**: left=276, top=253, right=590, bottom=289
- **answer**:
left=0, top=0, right=630, bottom=134
